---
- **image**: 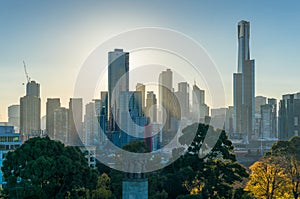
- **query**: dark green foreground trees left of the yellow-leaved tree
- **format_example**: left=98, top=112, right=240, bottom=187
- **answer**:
left=2, top=123, right=252, bottom=199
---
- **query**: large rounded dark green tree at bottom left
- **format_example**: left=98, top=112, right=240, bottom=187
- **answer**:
left=2, top=137, right=97, bottom=198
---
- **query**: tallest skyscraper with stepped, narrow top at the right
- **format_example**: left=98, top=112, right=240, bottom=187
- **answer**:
left=233, top=21, right=255, bottom=139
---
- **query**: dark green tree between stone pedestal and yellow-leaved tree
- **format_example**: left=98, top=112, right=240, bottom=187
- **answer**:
left=162, top=124, right=248, bottom=198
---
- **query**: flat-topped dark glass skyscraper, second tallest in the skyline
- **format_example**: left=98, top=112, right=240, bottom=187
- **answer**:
left=108, top=49, right=129, bottom=131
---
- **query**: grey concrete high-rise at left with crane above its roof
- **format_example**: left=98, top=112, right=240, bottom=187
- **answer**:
left=20, top=81, right=41, bottom=141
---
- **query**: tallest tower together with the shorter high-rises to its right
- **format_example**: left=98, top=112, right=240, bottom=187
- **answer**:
left=232, top=21, right=300, bottom=142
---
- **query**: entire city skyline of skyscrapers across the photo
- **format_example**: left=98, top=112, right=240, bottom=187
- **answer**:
left=2, top=21, right=300, bottom=154
